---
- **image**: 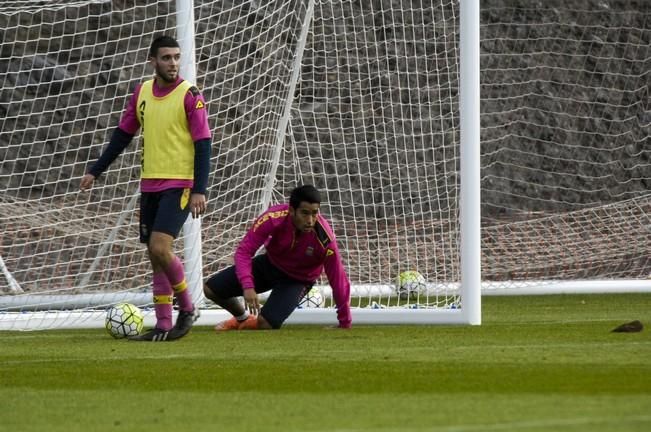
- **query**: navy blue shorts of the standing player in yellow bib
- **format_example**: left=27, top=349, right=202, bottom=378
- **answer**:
left=140, top=188, right=190, bottom=243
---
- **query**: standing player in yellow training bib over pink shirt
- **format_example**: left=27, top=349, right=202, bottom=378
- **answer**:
left=80, top=36, right=211, bottom=342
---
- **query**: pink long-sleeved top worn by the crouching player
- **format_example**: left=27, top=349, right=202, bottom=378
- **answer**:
left=235, top=204, right=351, bottom=327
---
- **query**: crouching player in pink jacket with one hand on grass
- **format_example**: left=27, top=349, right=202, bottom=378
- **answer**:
left=204, top=185, right=352, bottom=332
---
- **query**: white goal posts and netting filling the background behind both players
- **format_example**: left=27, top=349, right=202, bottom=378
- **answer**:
left=0, top=0, right=651, bottom=330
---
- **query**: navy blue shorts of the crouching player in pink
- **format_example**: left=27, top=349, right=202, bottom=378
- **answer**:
left=206, top=254, right=314, bottom=329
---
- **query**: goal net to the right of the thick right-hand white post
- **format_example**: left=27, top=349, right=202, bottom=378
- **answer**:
left=481, top=0, right=651, bottom=293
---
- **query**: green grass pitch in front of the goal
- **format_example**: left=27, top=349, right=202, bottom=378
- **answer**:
left=0, top=294, right=651, bottom=432
